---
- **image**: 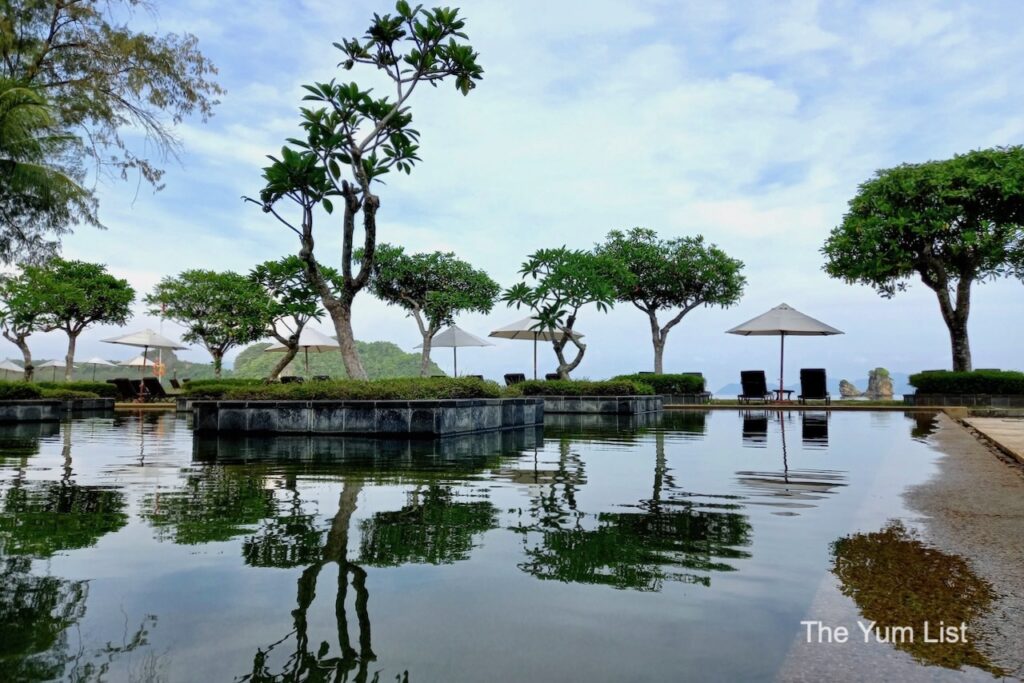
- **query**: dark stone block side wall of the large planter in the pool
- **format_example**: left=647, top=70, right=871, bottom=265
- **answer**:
left=193, top=397, right=544, bottom=437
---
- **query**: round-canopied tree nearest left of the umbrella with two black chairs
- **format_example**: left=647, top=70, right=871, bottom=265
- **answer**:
left=597, top=227, right=746, bottom=375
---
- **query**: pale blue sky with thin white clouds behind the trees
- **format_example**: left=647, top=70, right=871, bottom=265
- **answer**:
left=28, top=0, right=1024, bottom=388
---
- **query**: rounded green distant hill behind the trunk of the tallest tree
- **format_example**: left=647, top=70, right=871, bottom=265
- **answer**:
left=231, top=341, right=443, bottom=380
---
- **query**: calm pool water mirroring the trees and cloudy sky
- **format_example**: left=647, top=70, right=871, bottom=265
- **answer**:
left=0, top=411, right=958, bottom=681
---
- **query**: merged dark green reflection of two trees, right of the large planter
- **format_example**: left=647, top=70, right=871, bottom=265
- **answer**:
left=514, top=421, right=751, bottom=591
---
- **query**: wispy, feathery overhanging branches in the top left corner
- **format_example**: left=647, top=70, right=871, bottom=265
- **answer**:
left=0, top=0, right=223, bottom=189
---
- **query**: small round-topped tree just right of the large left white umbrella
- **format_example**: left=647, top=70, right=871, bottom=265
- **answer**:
left=145, top=269, right=270, bottom=377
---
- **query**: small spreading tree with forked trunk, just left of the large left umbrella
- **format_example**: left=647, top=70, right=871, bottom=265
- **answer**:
left=24, top=258, right=135, bottom=381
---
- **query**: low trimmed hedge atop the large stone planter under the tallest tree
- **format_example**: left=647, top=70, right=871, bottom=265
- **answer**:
left=186, top=377, right=502, bottom=400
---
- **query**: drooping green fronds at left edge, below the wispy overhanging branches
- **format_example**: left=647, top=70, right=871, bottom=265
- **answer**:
left=0, top=77, right=99, bottom=263
